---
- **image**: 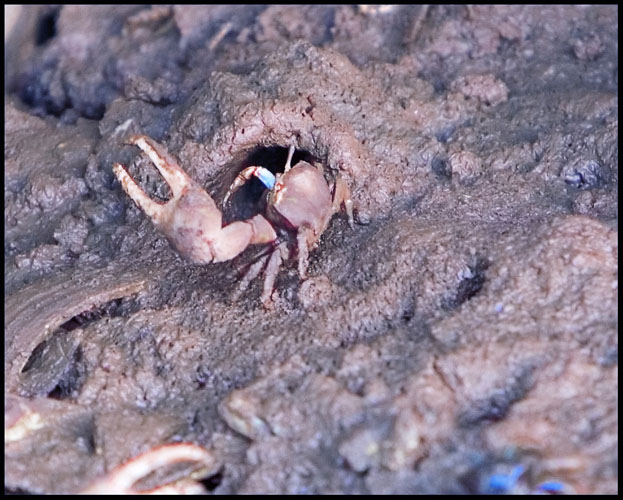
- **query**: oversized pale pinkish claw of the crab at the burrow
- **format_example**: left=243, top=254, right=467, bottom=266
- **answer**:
left=113, top=135, right=277, bottom=264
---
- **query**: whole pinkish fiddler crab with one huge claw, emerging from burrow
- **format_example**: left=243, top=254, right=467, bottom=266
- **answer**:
left=113, top=135, right=353, bottom=309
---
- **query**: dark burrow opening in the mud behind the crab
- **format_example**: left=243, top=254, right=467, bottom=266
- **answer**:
left=218, top=146, right=320, bottom=224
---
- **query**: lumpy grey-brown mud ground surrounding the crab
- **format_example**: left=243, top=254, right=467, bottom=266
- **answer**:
left=4, top=5, right=618, bottom=493
